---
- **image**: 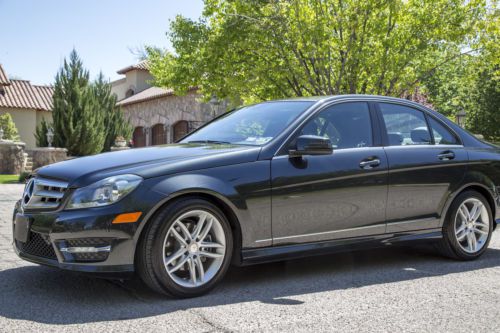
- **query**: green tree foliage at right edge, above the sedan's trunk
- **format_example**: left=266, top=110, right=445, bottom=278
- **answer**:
left=423, top=2, right=500, bottom=142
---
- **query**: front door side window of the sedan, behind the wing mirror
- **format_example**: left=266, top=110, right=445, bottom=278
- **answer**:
left=300, top=102, right=373, bottom=149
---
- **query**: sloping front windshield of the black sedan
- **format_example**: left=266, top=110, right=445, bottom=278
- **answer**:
left=181, top=101, right=314, bottom=146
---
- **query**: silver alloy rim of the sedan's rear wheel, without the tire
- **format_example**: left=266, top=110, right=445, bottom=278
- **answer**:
left=455, top=198, right=490, bottom=254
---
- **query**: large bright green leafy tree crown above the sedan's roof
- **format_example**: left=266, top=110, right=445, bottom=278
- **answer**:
left=148, top=0, right=485, bottom=101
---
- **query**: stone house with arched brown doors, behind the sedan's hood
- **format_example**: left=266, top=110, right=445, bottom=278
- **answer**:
left=111, top=60, right=226, bottom=147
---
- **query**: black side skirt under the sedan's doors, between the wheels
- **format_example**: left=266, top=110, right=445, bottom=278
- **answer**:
left=241, top=228, right=443, bottom=265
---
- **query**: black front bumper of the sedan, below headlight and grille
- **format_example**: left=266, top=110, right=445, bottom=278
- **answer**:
left=12, top=186, right=159, bottom=276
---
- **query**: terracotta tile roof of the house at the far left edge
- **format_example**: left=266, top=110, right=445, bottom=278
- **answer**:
left=0, top=80, right=54, bottom=111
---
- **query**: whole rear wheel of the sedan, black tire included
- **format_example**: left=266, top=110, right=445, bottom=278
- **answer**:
left=437, top=190, right=494, bottom=260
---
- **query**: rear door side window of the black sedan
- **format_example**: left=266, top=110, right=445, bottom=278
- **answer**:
left=379, top=103, right=432, bottom=146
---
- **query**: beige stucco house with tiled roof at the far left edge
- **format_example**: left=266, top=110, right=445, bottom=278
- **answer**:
left=0, top=64, right=54, bottom=149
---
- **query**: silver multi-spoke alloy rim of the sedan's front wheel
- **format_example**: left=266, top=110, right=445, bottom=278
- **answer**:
left=163, top=210, right=226, bottom=288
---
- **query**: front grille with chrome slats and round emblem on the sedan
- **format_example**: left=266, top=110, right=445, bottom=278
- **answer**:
left=22, top=178, right=68, bottom=209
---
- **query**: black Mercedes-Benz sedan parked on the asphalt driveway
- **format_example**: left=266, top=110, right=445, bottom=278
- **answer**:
left=13, top=95, right=500, bottom=297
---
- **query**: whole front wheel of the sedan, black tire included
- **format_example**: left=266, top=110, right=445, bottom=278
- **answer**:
left=136, top=198, right=233, bottom=298
